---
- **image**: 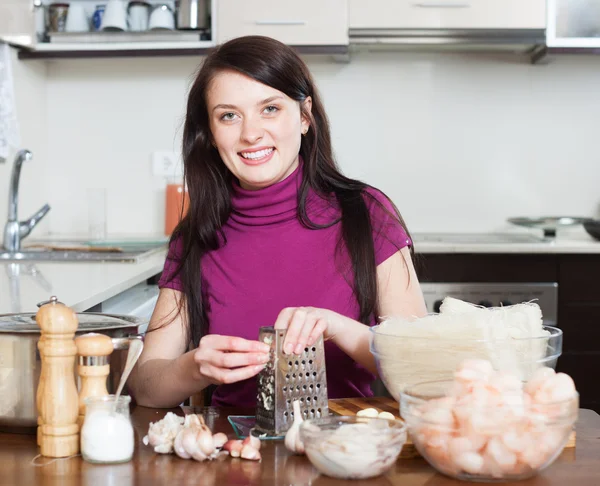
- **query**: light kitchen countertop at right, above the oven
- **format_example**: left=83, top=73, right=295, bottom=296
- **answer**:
left=412, top=228, right=600, bottom=254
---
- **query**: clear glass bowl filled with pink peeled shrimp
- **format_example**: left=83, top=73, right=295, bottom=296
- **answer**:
left=401, top=381, right=579, bottom=482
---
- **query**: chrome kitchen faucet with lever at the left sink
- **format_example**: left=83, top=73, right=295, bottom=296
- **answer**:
left=3, top=150, right=50, bottom=252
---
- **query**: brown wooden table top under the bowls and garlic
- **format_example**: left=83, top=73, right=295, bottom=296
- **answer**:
left=0, top=407, right=600, bottom=486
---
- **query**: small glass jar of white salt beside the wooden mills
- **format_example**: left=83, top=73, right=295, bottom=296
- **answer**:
left=80, top=395, right=134, bottom=464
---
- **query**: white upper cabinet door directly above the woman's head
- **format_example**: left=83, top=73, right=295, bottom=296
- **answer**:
left=217, top=0, right=348, bottom=45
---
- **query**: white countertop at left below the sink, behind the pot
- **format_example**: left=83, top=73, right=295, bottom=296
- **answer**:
left=0, top=249, right=167, bottom=314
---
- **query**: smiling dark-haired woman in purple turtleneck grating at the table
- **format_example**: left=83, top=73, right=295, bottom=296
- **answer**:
left=131, top=36, right=426, bottom=407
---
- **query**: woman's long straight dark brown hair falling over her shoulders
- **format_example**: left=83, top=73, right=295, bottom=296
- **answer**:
left=164, top=36, right=406, bottom=346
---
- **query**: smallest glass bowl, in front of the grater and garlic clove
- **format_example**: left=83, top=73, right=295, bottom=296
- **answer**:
left=300, top=416, right=406, bottom=479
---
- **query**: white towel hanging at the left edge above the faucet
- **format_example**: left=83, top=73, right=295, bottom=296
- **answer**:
left=0, top=43, right=20, bottom=162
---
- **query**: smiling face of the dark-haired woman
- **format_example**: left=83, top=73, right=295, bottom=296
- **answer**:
left=207, top=71, right=311, bottom=190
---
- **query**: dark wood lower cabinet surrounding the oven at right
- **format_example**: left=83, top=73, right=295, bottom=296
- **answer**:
left=415, top=253, right=600, bottom=412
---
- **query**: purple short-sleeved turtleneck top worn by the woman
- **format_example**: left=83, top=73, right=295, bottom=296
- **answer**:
left=159, top=164, right=411, bottom=407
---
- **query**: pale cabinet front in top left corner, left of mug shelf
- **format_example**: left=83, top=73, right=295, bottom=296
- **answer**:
left=0, top=0, right=35, bottom=45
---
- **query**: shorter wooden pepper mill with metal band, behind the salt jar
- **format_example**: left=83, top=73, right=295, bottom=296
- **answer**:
left=75, top=332, right=113, bottom=428
